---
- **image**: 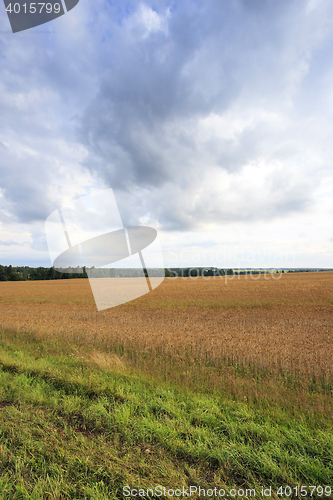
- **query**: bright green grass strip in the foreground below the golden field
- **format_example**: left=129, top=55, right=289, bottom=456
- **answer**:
left=0, top=332, right=333, bottom=500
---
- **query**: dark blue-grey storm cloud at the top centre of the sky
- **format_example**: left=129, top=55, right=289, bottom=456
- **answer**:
left=81, top=2, right=249, bottom=187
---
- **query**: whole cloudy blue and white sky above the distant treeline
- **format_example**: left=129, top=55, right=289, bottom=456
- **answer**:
left=0, top=0, right=333, bottom=268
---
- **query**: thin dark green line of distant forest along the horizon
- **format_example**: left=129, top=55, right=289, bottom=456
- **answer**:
left=0, top=265, right=333, bottom=281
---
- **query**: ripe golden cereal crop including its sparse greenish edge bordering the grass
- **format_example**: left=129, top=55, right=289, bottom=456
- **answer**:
left=0, top=272, right=333, bottom=411
